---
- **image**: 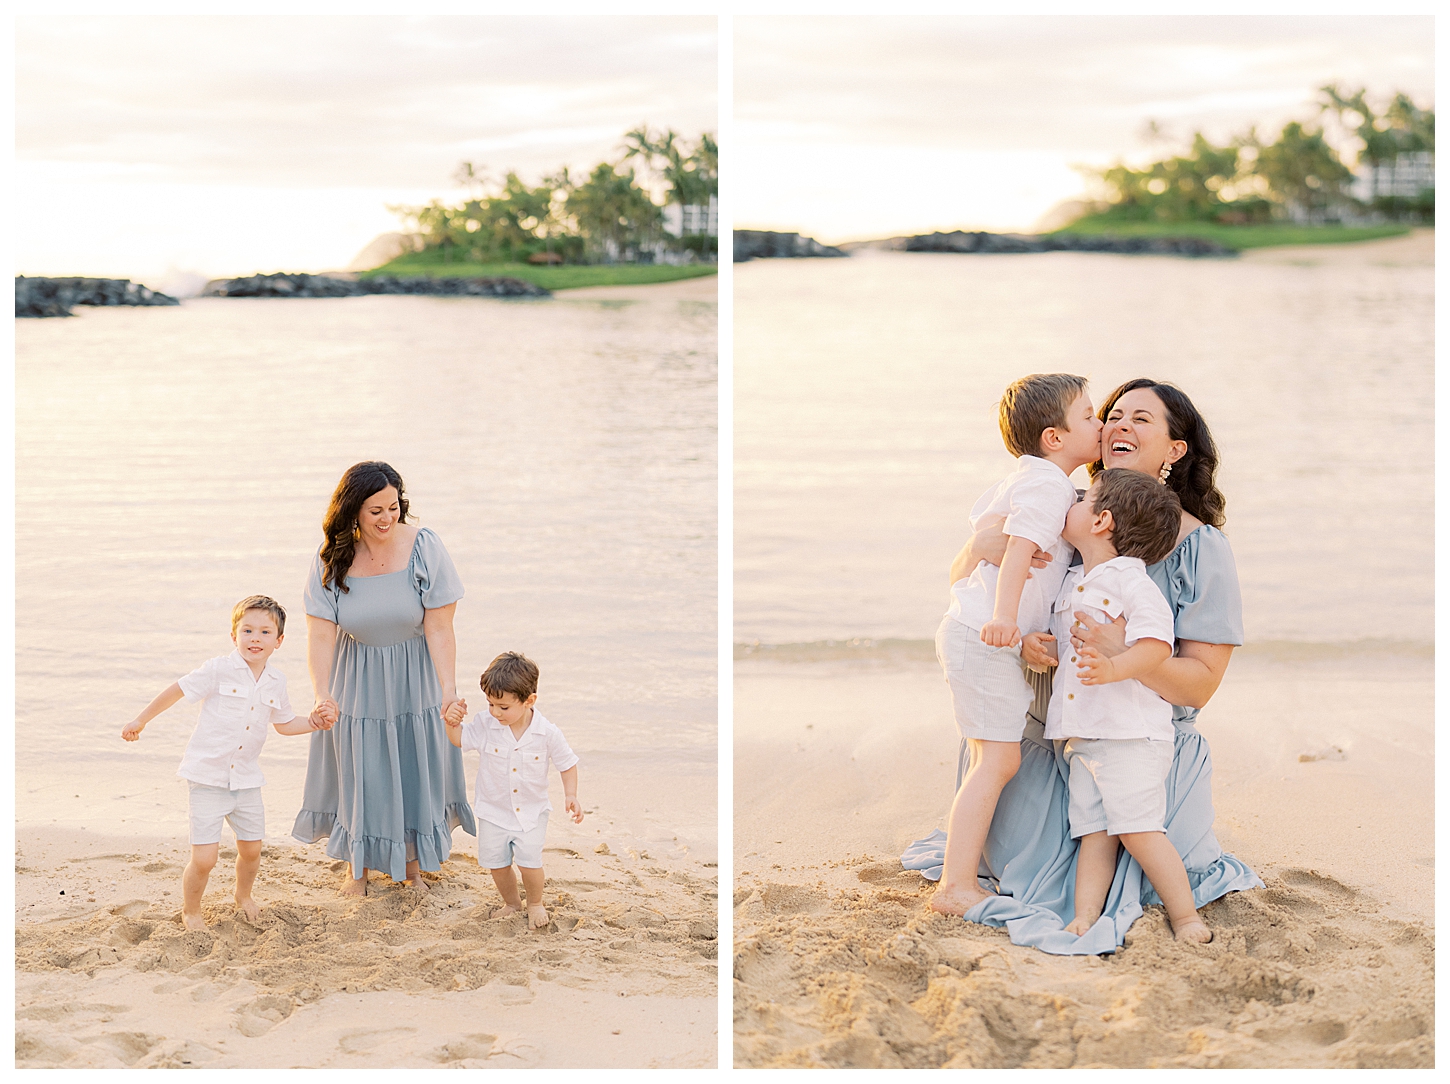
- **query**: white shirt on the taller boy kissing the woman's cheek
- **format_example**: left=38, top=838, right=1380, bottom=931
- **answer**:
left=947, top=455, right=1077, bottom=635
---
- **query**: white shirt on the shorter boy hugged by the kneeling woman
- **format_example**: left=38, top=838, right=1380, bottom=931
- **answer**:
left=1045, top=556, right=1175, bottom=741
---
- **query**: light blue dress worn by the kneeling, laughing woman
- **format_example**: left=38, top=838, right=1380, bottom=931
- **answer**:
left=902, top=526, right=1263, bottom=955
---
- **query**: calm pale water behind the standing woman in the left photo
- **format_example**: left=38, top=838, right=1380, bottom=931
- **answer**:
left=16, top=294, right=716, bottom=839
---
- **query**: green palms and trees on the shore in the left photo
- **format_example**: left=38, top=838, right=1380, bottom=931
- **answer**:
left=389, top=125, right=719, bottom=264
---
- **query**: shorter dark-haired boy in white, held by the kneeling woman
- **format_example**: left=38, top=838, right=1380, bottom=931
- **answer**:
left=1038, top=470, right=1214, bottom=942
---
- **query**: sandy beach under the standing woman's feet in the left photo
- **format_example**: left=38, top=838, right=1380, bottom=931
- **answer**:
left=16, top=820, right=716, bottom=1068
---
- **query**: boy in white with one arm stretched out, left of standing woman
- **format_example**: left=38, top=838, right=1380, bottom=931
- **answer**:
left=120, top=594, right=336, bottom=930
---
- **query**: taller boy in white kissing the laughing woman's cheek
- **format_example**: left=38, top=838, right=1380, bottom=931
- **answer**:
left=931, top=372, right=1102, bottom=914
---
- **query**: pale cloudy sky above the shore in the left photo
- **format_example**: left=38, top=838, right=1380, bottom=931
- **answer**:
left=12, top=14, right=718, bottom=288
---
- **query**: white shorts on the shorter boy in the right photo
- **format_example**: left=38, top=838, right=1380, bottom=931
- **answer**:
left=1063, top=738, right=1173, bottom=839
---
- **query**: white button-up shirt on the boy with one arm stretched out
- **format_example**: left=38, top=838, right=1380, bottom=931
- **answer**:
left=177, top=651, right=297, bottom=790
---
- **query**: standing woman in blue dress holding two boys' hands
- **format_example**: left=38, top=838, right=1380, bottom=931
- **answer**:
left=291, top=462, right=476, bottom=896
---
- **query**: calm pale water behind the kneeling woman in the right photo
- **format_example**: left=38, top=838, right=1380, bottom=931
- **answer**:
left=734, top=244, right=1434, bottom=652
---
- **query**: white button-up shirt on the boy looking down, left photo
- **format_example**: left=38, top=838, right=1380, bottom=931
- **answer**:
left=463, top=707, right=579, bottom=832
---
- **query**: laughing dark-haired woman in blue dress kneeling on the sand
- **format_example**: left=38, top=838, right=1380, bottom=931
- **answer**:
left=902, top=380, right=1263, bottom=955
